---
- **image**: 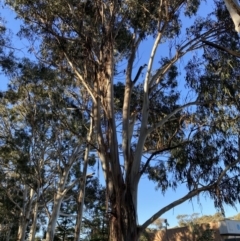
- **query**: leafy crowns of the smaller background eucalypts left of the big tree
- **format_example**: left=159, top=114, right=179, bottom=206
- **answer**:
left=0, top=51, right=95, bottom=240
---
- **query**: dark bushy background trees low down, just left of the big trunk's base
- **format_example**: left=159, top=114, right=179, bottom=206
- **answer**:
left=50, top=175, right=108, bottom=240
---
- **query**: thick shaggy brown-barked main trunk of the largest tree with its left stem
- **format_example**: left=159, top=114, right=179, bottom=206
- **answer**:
left=98, top=37, right=138, bottom=241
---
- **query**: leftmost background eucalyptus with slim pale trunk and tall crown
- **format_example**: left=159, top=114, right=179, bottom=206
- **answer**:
left=1, top=58, right=64, bottom=240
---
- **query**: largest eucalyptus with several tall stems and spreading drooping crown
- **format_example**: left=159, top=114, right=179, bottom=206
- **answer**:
left=3, top=0, right=240, bottom=241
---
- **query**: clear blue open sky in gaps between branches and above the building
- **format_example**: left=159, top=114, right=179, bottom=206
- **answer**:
left=0, top=1, right=239, bottom=230
